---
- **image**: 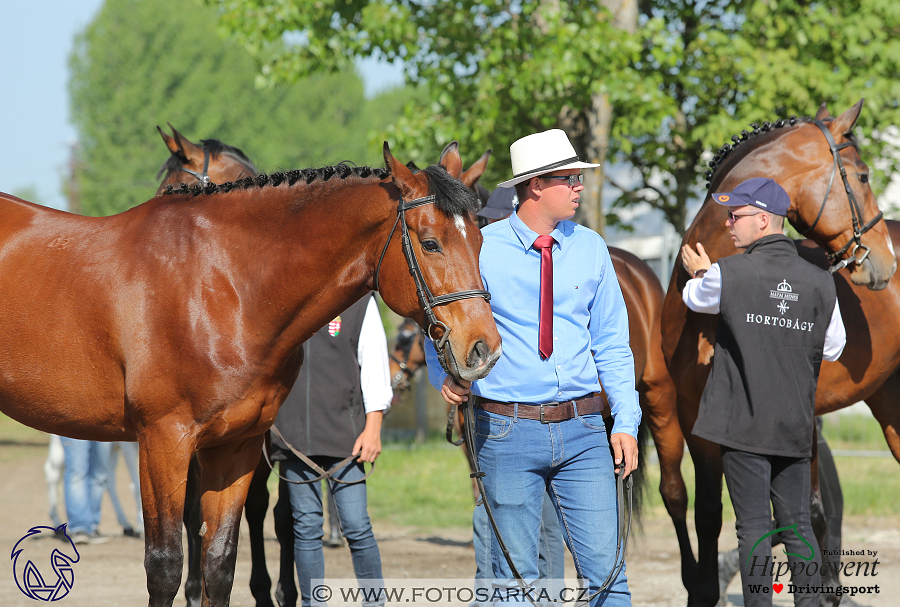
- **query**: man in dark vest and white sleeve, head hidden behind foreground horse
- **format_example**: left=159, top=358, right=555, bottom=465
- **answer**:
left=272, top=295, right=393, bottom=607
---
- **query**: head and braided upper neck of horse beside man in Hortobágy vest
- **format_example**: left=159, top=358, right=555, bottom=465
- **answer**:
left=696, top=100, right=897, bottom=290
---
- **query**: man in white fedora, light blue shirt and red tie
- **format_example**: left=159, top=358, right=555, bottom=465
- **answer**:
left=426, top=129, right=641, bottom=607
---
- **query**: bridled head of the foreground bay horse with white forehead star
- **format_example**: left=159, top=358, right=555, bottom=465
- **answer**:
left=374, top=141, right=500, bottom=380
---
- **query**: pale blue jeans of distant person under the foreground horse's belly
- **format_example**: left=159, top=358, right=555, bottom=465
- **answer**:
left=60, top=436, right=112, bottom=536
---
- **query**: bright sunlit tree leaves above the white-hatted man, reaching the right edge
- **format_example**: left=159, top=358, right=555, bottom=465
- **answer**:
left=205, top=0, right=900, bottom=231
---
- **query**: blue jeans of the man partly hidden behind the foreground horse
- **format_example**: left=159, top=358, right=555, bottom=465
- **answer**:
left=282, top=456, right=384, bottom=607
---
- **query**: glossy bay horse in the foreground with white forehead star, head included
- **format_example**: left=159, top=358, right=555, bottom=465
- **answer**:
left=0, top=142, right=500, bottom=607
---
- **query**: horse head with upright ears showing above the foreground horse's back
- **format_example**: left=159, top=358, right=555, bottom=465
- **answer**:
left=156, top=122, right=257, bottom=196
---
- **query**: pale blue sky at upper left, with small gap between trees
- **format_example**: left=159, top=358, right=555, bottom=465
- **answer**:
left=0, top=0, right=403, bottom=214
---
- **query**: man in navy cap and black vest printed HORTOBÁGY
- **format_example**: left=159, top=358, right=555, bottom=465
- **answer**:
left=681, top=177, right=846, bottom=607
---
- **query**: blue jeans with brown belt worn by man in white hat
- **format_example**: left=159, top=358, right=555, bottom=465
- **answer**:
left=475, top=408, right=631, bottom=607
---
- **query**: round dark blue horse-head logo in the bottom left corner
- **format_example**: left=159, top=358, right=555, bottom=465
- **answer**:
left=10, top=523, right=81, bottom=603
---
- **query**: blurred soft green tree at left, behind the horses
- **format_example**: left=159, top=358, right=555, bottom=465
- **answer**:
left=70, top=0, right=399, bottom=215
